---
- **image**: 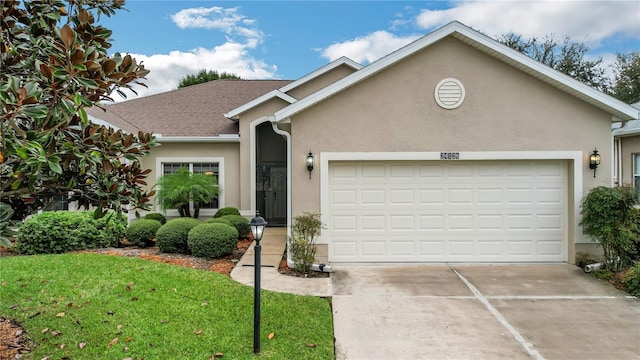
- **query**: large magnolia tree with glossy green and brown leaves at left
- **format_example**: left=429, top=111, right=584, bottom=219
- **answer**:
left=0, top=0, right=156, bottom=218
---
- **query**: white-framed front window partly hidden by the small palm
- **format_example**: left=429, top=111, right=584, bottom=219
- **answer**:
left=156, top=157, right=224, bottom=215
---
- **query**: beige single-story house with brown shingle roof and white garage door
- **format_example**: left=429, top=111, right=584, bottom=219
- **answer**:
left=91, top=22, right=638, bottom=264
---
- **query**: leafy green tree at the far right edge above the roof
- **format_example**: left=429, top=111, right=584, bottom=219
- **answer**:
left=611, top=51, right=640, bottom=104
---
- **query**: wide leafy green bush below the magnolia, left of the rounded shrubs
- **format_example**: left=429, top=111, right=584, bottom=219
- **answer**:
left=15, top=211, right=126, bottom=255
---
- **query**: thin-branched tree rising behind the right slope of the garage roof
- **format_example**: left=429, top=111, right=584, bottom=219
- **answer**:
left=498, top=33, right=611, bottom=92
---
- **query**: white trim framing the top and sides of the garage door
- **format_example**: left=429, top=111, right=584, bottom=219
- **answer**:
left=318, top=151, right=591, bottom=261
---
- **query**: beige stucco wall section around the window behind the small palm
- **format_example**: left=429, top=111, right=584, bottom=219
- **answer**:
left=141, top=142, right=240, bottom=212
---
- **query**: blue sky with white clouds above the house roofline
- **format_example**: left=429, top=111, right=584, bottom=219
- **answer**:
left=100, top=0, right=640, bottom=100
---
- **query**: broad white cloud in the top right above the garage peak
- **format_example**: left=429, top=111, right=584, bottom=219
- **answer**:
left=416, top=0, right=640, bottom=49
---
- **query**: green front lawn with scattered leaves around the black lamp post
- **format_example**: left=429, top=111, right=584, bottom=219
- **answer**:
left=0, top=254, right=334, bottom=360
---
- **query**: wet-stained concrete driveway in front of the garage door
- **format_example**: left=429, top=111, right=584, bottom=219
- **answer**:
left=332, top=264, right=640, bottom=360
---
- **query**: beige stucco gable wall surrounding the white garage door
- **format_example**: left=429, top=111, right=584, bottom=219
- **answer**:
left=291, top=38, right=611, bottom=259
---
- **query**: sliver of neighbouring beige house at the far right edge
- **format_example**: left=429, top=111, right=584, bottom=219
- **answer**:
left=613, top=102, right=640, bottom=191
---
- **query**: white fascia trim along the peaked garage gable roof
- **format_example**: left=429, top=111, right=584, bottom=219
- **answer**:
left=274, top=21, right=638, bottom=122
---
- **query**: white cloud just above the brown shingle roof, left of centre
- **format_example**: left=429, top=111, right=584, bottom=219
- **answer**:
left=113, top=42, right=277, bottom=102
